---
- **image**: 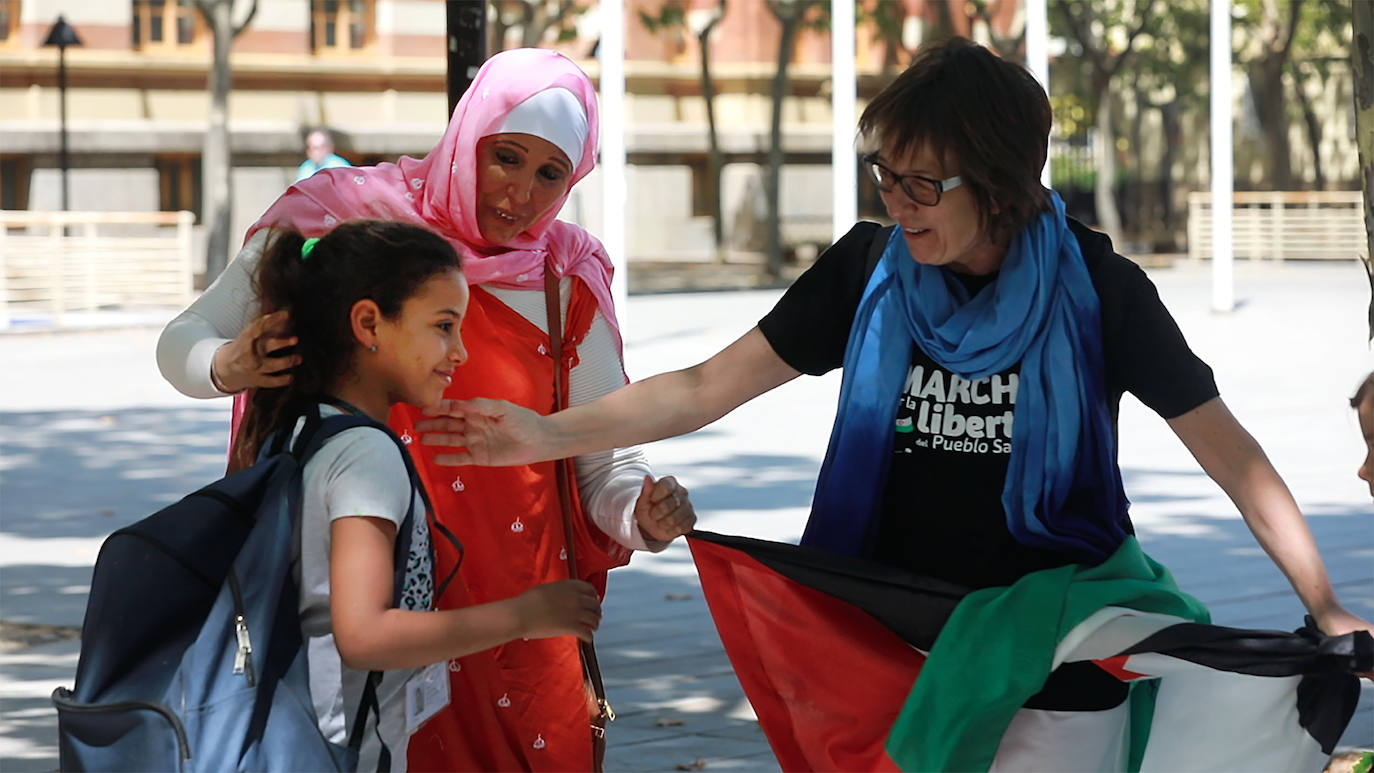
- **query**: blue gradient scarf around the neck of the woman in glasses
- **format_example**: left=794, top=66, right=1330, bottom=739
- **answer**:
left=801, top=192, right=1127, bottom=564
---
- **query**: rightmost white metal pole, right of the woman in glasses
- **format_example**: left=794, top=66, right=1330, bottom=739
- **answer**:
left=1210, top=0, right=1235, bottom=312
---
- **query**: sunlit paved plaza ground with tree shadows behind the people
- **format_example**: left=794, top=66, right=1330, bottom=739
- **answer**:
left=0, top=256, right=1374, bottom=772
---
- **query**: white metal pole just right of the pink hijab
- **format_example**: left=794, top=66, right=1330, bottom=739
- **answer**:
left=596, top=0, right=629, bottom=326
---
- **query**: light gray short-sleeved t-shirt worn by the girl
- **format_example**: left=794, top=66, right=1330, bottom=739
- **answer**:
left=295, top=405, right=434, bottom=770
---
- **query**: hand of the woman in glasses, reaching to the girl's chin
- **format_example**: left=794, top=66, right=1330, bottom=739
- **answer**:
left=415, top=398, right=550, bottom=467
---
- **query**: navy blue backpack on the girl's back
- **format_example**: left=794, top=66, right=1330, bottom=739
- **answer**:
left=52, top=409, right=427, bottom=772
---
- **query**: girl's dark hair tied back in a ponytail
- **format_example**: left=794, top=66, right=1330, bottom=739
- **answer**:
left=232, top=220, right=460, bottom=467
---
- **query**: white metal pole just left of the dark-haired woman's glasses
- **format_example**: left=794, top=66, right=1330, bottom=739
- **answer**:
left=830, top=0, right=859, bottom=242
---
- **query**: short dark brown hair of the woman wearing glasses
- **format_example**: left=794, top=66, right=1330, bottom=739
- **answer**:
left=859, top=37, right=1051, bottom=238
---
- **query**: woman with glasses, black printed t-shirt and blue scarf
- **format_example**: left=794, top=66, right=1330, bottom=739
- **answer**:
left=425, top=38, right=1370, bottom=770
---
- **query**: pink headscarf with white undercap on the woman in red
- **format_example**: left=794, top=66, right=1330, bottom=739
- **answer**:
left=247, top=48, right=620, bottom=345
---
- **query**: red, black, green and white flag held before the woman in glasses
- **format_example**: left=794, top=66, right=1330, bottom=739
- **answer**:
left=688, top=531, right=1374, bottom=773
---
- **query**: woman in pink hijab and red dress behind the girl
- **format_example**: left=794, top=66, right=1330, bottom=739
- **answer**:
left=158, top=49, right=695, bottom=770
